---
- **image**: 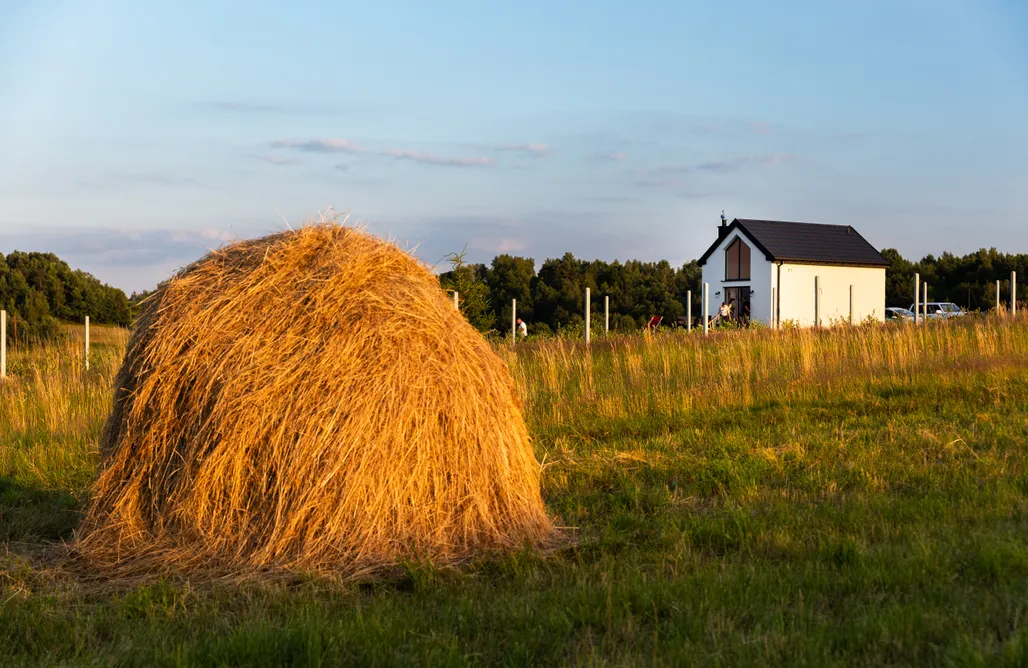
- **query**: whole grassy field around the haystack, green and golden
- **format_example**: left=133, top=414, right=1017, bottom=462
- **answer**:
left=0, top=319, right=1028, bottom=666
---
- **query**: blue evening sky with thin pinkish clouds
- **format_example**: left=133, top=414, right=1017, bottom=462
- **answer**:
left=0, top=0, right=1028, bottom=291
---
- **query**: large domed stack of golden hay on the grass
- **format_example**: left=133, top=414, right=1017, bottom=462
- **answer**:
left=71, top=222, right=554, bottom=579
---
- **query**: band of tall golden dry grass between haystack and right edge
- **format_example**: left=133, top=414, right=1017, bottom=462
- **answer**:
left=501, top=317, right=1028, bottom=425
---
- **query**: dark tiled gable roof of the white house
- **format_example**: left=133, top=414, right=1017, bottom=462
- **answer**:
left=699, top=218, right=889, bottom=267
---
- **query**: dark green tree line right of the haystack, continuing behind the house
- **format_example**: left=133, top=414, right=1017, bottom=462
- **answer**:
left=440, top=249, right=1028, bottom=334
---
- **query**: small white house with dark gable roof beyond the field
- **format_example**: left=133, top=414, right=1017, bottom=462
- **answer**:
left=699, top=216, right=889, bottom=327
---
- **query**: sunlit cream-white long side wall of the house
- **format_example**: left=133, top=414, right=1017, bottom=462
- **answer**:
left=777, top=263, right=885, bottom=327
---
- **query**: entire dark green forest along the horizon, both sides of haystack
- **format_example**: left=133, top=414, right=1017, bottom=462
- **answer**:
left=0, top=244, right=1028, bottom=340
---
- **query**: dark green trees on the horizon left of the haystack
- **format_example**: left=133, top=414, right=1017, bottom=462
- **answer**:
left=0, top=251, right=131, bottom=340
